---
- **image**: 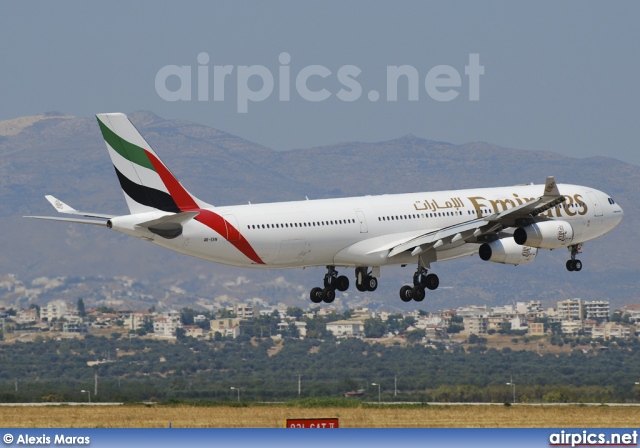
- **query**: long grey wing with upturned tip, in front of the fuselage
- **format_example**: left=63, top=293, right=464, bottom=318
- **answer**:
left=387, top=176, right=566, bottom=258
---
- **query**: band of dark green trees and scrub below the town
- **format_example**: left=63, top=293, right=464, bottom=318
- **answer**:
left=0, top=331, right=640, bottom=403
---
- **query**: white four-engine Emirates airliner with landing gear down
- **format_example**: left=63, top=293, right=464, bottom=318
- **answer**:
left=29, top=113, right=624, bottom=303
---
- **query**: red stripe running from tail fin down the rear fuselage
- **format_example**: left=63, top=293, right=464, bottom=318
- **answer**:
left=145, top=150, right=264, bottom=264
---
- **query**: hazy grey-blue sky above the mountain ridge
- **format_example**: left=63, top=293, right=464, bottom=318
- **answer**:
left=0, top=1, right=640, bottom=164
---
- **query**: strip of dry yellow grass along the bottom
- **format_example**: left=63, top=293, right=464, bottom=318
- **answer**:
left=0, top=405, right=640, bottom=428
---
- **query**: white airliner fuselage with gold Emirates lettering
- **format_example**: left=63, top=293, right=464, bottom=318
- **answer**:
left=139, top=184, right=623, bottom=269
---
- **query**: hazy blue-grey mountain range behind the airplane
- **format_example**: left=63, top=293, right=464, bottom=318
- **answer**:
left=0, top=111, right=640, bottom=310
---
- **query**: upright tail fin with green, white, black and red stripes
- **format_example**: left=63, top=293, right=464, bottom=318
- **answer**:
left=96, top=113, right=212, bottom=214
